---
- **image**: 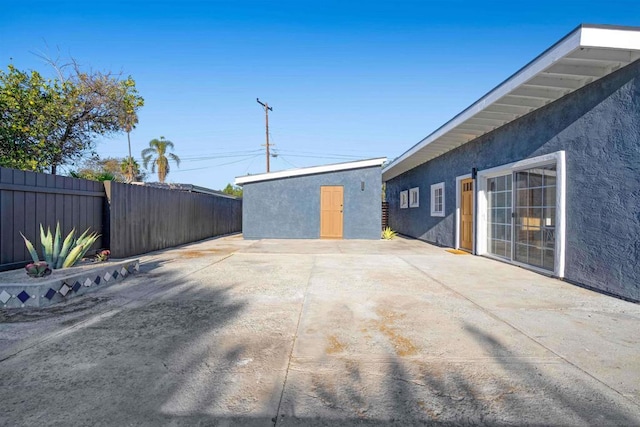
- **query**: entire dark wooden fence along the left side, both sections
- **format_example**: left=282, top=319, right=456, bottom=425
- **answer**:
left=0, top=167, right=242, bottom=271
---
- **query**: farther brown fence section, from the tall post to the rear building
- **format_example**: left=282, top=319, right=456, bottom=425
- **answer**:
left=105, top=181, right=242, bottom=258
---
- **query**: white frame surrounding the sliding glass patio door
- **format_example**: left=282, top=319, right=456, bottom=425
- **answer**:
left=476, top=151, right=567, bottom=278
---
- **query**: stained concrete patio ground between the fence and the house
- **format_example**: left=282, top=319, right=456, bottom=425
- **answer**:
left=0, top=236, right=640, bottom=426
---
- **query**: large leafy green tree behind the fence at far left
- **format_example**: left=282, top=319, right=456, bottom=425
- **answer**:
left=0, top=61, right=144, bottom=174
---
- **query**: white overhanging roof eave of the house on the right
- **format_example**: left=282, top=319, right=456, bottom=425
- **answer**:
left=382, top=25, right=640, bottom=181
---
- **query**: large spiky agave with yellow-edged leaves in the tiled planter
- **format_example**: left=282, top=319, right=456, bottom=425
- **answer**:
left=20, top=222, right=100, bottom=268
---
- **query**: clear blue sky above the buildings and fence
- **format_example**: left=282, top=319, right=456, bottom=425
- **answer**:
left=0, top=0, right=640, bottom=189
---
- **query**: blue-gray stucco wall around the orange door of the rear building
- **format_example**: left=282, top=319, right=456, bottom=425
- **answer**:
left=242, top=166, right=382, bottom=239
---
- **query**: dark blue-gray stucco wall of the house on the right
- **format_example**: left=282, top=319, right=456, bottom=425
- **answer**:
left=387, top=61, right=640, bottom=301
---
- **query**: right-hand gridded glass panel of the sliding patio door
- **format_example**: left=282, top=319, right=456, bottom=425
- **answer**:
left=513, top=165, right=556, bottom=271
